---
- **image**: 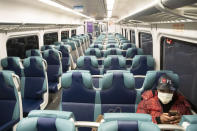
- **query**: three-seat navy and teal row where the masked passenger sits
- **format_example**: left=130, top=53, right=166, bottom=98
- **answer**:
left=60, top=70, right=178, bottom=121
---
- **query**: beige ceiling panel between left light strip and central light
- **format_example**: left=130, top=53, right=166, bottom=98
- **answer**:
left=56, top=0, right=107, bottom=19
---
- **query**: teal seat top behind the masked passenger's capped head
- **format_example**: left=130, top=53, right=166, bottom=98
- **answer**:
left=143, top=70, right=179, bottom=90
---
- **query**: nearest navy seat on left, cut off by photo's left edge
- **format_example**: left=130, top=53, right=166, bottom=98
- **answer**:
left=0, top=71, right=22, bottom=131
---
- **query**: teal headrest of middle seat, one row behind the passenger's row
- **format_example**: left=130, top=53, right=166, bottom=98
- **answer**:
left=104, top=55, right=126, bottom=67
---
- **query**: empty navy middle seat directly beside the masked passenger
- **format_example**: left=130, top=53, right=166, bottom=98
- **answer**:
left=100, top=71, right=141, bottom=113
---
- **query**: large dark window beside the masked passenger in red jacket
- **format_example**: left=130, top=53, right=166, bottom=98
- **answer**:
left=161, top=37, right=197, bottom=109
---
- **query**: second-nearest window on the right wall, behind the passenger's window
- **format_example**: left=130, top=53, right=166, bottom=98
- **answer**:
left=139, top=32, right=153, bottom=55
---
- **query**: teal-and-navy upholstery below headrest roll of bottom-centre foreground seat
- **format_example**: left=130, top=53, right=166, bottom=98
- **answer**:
left=98, top=120, right=160, bottom=131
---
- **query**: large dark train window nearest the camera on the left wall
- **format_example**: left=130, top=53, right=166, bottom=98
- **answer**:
left=6, top=35, right=39, bottom=59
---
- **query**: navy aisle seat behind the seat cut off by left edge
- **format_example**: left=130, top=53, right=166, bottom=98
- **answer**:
left=21, top=56, right=48, bottom=100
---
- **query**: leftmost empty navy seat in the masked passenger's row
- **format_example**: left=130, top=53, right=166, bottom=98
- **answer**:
left=61, top=71, right=96, bottom=121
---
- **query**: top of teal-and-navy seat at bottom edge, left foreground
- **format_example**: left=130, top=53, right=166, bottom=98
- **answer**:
left=16, top=110, right=76, bottom=131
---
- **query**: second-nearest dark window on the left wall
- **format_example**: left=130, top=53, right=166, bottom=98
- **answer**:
left=44, top=32, right=58, bottom=45
